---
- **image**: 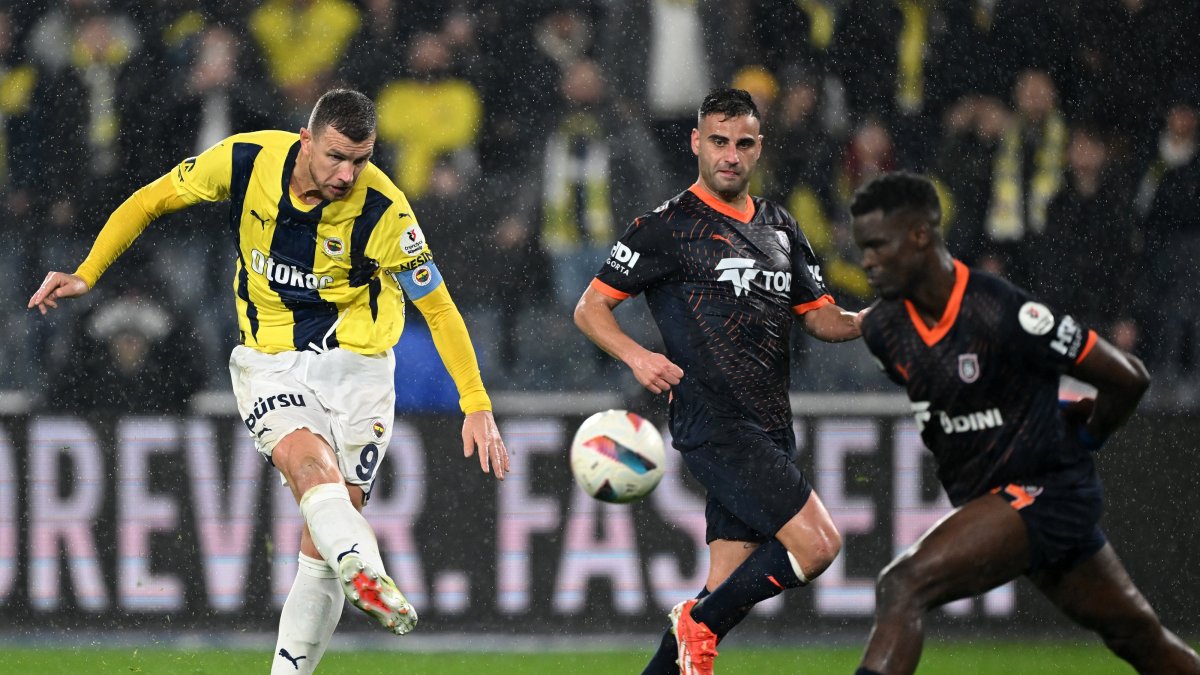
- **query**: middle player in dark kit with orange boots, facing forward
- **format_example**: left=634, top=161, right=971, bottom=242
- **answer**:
left=575, top=89, right=859, bottom=674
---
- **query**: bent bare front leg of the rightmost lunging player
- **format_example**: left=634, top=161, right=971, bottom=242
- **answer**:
left=858, top=495, right=1030, bottom=675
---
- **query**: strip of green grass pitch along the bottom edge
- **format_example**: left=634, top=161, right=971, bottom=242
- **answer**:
left=0, top=643, right=1152, bottom=675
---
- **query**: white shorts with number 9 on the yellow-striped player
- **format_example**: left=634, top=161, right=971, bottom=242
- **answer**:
left=229, top=345, right=396, bottom=492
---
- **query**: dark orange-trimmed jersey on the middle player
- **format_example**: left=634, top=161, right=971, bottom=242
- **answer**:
left=592, top=184, right=833, bottom=450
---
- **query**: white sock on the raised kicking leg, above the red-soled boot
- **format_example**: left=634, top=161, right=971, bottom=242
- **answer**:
left=300, top=483, right=385, bottom=574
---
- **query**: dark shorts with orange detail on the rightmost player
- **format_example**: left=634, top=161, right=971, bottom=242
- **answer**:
left=992, top=468, right=1108, bottom=572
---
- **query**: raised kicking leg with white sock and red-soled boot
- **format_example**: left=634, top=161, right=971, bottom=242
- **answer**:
left=271, top=429, right=416, bottom=635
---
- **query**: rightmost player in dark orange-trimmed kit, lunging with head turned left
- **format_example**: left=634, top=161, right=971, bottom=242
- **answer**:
left=850, top=172, right=1200, bottom=675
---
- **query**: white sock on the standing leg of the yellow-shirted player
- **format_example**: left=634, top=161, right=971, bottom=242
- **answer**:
left=271, top=554, right=343, bottom=675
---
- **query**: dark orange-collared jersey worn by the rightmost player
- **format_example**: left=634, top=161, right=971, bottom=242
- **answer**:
left=863, top=261, right=1097, bottom=506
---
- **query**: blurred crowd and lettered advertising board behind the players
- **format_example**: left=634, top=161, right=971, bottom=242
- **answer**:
left=0, top=0, right=1200, bottom=667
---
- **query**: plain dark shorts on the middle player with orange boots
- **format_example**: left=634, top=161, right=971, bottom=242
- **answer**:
left=683, top=428, right=812, bottom=542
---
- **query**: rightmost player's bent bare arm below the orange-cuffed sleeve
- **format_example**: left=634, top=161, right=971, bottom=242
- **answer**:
left=1070, top=336, right=1150, bottom=448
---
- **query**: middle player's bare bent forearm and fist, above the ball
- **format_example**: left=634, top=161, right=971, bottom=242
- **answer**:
left=575, top=288, right=683, bottom=394
